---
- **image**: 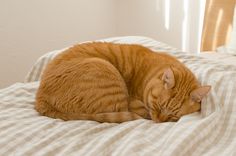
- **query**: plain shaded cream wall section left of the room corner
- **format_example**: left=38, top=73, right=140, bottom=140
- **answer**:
left=0, top=0, right=116, bottom=88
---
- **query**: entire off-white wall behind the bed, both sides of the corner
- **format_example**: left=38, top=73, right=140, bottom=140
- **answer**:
left=0, top=0, right=205, bottom=88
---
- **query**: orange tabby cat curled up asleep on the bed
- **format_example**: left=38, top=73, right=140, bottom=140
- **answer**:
left=35, top=42, right=211, bottom=123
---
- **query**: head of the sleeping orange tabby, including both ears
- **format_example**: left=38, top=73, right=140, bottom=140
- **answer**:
left=147, top=68, right=211, bottom=122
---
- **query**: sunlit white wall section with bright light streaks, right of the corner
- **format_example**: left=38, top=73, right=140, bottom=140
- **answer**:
left=117, top=0, right=205, bottom=52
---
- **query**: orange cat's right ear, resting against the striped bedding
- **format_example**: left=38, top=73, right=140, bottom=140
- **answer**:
left=190, top=86, right=211, bottom=102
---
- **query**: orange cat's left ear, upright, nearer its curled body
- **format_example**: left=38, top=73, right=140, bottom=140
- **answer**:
left=161, top=68, right=175, bottom=89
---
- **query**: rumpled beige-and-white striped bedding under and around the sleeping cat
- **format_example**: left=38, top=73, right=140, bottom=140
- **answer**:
left=0, top=36, right=236, bottom=156
